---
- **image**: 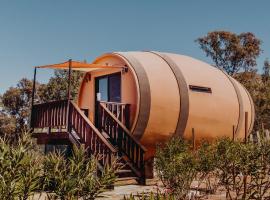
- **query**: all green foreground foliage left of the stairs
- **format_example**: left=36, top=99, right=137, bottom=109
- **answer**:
left=0, top=134, right=116, bottom=200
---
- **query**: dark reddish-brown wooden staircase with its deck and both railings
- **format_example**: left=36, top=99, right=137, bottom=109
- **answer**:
left=31, top=100, right=146, bottom=184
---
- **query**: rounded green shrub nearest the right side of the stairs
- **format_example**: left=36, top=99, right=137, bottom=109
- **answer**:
left=155, top=137, right=197, bottom=199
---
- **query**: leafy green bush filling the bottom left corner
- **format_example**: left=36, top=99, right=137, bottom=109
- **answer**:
left=0, top=133, right=42, bottom=200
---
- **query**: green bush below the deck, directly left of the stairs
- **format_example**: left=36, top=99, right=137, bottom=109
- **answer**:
left=44, top=147, right=116, bottom=200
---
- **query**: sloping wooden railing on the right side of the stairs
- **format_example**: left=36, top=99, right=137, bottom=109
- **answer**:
left=99, top=102, right=146, bottom=176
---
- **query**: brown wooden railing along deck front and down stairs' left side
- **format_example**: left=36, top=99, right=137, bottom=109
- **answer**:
left=31, top=100, right=117, bottom=166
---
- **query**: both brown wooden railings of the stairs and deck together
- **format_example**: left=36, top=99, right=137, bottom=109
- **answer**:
left=31, top=100, right=146, bottom=180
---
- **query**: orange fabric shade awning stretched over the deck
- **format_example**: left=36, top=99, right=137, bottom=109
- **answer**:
left=37, top=61, right=124, bottom=72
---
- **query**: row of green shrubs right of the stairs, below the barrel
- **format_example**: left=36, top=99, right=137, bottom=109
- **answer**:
left=150, top=138, right=270, bottom=200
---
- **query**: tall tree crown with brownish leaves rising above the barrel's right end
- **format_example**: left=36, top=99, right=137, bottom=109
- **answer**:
left=195, top=31, right=261, bottom=76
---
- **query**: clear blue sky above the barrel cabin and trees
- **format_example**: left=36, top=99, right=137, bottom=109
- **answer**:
left=0, top=0, right=270, bottom=94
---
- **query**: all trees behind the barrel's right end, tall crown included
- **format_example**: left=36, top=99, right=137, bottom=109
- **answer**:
left=196, top=31, right=270, bottom=130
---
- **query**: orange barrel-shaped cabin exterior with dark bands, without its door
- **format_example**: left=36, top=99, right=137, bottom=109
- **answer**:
left=78, top=52, right=254, bottom=159
